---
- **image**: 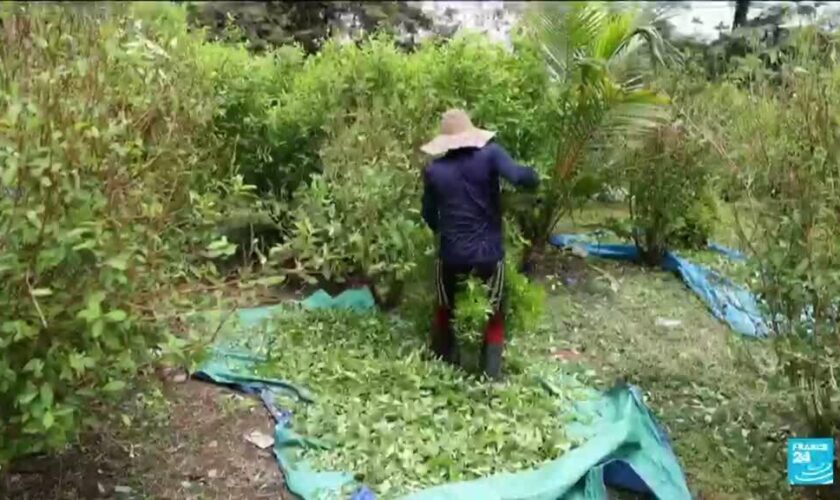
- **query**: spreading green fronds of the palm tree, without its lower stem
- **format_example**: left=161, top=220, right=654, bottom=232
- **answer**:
left=529, top=2, right=676, bottom=189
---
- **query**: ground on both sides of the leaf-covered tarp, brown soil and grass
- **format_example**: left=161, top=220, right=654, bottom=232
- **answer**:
left=0, top=207, right=794, bottom=500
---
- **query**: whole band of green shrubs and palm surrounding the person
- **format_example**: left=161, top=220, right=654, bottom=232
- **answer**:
left=0, top=2, right=840, bottom=498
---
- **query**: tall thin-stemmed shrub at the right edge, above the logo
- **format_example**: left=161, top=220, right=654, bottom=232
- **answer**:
left=751, top=39, right=840, bottom=446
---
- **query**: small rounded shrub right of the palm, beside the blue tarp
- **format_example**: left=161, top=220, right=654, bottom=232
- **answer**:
left=622, top=123, right=717, bottom=265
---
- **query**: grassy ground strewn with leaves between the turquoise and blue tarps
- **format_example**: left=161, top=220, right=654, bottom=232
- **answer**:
left=548, top=252, right=793, bottom=499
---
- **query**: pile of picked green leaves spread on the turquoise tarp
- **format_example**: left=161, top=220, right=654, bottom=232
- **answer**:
left=223, top=311, right=592, bottom=498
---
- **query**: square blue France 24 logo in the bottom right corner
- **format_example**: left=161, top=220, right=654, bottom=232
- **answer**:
left=788, top=438, right=834, bottom=486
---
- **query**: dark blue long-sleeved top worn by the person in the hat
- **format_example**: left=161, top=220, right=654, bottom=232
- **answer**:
left=422, top=142, right=539, bottom=265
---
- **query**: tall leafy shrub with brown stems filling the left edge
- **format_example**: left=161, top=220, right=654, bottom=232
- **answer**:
left=0, top=4, right=236, bottom=462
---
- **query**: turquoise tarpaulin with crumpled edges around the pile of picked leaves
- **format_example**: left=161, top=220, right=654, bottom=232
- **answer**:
left=194, top=289, right=691, bottom=500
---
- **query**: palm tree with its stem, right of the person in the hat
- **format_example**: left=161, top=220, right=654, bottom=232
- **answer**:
left=520, top=2, right=674, bottom=266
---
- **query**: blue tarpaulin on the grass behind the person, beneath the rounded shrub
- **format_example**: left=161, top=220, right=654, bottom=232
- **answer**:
left=549, top=234, right=769, bottom=337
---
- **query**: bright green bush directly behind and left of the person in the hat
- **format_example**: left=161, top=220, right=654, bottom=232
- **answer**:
left=274, top=31, right=546, bottom=304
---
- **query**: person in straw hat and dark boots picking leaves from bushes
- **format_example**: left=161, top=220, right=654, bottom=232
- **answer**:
left=421, top=109, right=539, bottom=380
